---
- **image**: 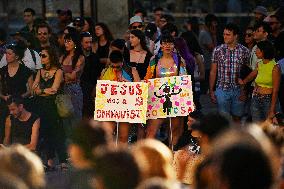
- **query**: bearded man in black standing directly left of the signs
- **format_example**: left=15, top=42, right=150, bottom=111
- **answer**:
left=80, top=32, right=103, bottom=119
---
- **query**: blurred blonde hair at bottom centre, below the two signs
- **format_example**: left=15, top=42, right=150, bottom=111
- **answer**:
left=132, top=139, right=175, bottom=180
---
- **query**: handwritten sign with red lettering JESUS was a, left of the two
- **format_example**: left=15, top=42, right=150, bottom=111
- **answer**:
left=94, top=80, right=148, bottom=123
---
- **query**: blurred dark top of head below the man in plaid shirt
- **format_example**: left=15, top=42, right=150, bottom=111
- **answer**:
left=191, top=112, right=231, bottom=139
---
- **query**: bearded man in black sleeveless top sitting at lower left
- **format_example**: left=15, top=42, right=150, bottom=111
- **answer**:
left=4, top=96, right=40, bottom=151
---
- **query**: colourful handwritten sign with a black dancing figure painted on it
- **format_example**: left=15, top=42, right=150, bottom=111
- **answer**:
left=147, top=75, right=194, bottom=119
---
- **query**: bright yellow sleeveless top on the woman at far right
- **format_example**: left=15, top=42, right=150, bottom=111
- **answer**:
left=255, top=60, right=277, bottom=88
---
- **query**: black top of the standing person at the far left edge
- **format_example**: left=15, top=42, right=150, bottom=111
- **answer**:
left=0, top=64, right=32, bottom=96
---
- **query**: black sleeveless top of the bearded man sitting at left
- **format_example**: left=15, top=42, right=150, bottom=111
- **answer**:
left=10, top=113, right=39, bottom=145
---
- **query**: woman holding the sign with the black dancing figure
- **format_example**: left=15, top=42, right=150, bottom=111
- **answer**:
left=145, top=35, right=187, bottom=145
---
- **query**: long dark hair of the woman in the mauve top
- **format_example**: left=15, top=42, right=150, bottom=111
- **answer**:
left=62, top=33, right=83, bottom=69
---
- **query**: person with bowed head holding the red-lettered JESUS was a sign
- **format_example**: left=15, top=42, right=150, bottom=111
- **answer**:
left=100, top=50, right=140, bottom=143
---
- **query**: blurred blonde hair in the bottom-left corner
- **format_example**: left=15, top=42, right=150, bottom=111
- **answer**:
left=0, top=145, right=45, bottom=189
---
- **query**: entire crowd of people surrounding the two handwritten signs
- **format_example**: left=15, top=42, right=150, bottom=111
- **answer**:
left=0, top=3, right=284, bottom=189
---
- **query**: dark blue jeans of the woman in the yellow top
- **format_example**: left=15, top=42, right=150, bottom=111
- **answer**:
left=251, top=94, right=272, bottom=122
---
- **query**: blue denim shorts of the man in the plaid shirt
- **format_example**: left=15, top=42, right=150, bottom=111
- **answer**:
left=215, top=87, right=245, bottom=117
